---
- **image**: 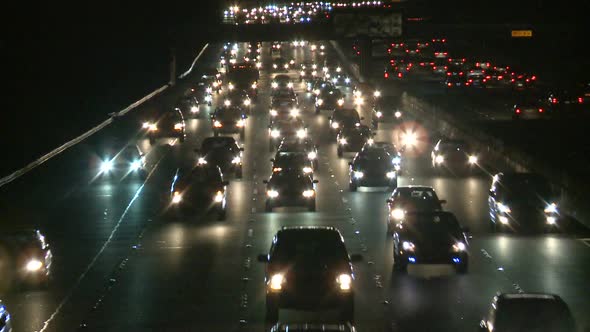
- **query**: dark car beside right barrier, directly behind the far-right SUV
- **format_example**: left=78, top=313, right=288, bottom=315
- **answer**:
left=430, top=138, right=481, bottom=174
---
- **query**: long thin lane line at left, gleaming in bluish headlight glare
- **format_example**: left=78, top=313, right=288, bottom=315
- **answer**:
left=39, top=148, right=167, bottom=332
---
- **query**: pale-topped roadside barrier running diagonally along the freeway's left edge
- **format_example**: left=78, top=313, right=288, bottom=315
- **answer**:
left=0, top=44, right=209, bottom=188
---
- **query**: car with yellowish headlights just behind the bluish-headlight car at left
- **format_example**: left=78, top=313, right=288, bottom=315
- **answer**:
left=142, top=108, right=186, bottom=144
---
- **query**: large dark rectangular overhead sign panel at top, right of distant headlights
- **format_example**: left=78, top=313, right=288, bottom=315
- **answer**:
left=333, top=12, right=402, bottom=38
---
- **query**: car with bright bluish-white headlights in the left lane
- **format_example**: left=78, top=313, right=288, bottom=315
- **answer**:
left=90, top=140, right=148, bottom=181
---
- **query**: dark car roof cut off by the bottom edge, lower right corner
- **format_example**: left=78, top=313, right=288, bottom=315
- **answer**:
left=479, top=293, right=578, bottom=332
